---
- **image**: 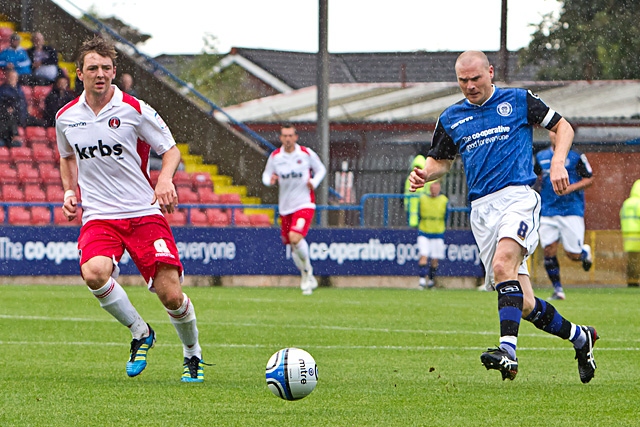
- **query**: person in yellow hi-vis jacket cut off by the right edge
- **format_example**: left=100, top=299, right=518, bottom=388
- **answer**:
left=620, top=179, right=640, bottom=288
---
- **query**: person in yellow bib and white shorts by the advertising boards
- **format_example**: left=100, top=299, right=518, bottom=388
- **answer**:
left=417, top=181, right=449, bottom=289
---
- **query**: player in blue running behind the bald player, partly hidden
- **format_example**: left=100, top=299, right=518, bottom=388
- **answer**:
left=534, top=131, right=593, bottom=299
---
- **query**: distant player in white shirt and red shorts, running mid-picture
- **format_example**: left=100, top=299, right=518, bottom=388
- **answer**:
left=262, top=125, right=327, bottom=295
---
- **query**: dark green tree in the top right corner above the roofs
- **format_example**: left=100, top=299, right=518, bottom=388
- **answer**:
left=521, top=0, right=640, bottom=80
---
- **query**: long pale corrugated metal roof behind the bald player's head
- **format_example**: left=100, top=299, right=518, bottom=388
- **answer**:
left=216, top=80, right=640, bottom=122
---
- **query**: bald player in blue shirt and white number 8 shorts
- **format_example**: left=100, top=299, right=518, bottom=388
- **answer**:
left=410, top=51, right=598, bottom=383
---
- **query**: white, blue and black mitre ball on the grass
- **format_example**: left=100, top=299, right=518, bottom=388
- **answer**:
left=266, top=347, right=318, bottom=400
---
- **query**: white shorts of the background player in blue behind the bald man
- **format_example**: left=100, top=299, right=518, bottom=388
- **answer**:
left=540, top=215, right=584, bottom=254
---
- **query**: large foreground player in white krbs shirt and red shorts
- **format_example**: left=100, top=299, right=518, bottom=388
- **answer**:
left=56, top=36, right=205, bottom=382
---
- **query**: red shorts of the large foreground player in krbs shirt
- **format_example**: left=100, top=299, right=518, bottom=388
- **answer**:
left=78, top=215, right=182, bottom=284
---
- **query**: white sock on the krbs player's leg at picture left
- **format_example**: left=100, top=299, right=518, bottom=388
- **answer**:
left=89, top=277, right=149, bottom=339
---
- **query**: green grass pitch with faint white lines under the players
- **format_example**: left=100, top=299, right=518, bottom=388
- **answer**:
left=0, top=286, right=640, bottom=427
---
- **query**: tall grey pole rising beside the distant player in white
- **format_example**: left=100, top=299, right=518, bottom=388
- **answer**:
left=316, top=0, right=331, bottom=227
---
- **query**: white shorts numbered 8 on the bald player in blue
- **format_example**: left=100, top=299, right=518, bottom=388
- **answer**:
left=471, top=185, right=540, bottom=290
